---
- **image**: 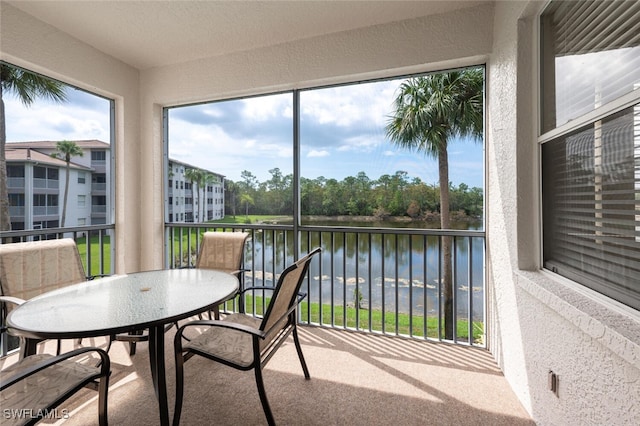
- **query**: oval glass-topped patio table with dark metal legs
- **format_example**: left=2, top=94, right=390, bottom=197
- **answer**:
left=7, top=269, right=239, bottom=425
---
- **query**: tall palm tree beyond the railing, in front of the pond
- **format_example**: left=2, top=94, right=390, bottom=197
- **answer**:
left=386, top=68, right=484, bottom=339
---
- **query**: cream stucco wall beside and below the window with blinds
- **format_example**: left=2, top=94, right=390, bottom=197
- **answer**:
left=487, top=2, right=640, bottom=426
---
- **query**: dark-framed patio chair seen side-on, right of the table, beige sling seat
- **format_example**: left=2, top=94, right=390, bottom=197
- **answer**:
left=173, top=248, right=320, bottom=425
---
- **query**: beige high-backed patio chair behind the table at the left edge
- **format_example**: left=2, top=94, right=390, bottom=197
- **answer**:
left=0, top=238, right=99, bottom=354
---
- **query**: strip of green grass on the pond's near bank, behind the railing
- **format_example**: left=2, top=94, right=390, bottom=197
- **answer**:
left=227, top=296, right=484, bottom=343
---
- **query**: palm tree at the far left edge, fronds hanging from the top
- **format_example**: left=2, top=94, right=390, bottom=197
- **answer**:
left=0, top=63, right=67, bottom=231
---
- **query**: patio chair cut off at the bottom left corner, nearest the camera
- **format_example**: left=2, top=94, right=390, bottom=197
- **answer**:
left=0, top=347, right=111, bottom=426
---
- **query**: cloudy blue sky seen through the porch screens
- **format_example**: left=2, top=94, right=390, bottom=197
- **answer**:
left=5, top=76, right=484, bottom=187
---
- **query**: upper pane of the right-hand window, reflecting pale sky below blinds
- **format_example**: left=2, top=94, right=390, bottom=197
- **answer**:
left=541, top=1, right=640, bottom=133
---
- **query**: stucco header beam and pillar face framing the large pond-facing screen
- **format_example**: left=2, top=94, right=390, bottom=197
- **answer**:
left=135, top=2, right=493, bottom=269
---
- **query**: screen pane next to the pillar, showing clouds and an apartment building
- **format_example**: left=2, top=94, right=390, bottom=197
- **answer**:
left=167, top=93, right=293, bottom=222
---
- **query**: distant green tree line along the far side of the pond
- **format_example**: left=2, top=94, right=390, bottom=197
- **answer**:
left=225, top=168, right=483, bottom=219
